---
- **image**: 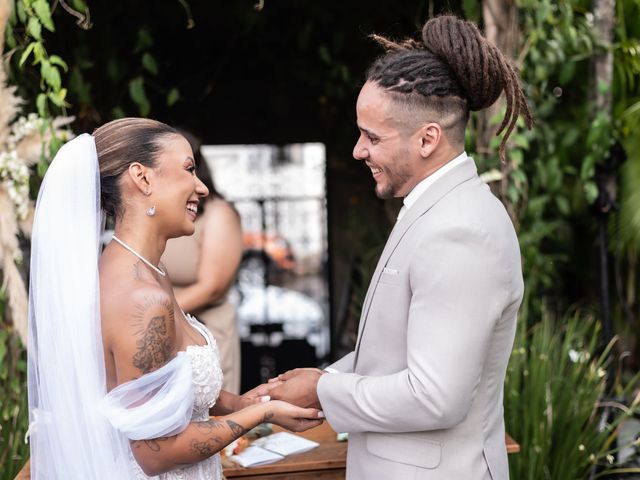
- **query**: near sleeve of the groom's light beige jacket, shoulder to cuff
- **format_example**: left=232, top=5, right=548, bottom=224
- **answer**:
left=318, top=225, right=509, bottom=432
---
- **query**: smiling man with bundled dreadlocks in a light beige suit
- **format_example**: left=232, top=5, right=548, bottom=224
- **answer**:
left=271, top=16, right=531, bottom=480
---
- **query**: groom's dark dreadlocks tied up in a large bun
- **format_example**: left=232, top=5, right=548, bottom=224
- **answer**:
left=367, top=15, right=533, bottom=161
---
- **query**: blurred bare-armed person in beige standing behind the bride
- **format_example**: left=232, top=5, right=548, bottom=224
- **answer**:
left=162, top=131, right=243, bottom=394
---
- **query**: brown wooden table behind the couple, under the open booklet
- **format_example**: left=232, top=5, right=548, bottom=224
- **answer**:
left=15, top=422, right=520, bottom=480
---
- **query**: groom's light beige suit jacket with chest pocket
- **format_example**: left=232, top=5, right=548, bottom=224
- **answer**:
left=318, top=159, right=523, bottom=480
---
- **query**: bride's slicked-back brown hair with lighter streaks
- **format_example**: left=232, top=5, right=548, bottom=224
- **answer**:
left=93, top=118, right=179, bottom=218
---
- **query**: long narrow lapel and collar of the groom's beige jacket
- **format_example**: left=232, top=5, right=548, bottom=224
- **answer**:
left=354, top=158, right=478, bottom=368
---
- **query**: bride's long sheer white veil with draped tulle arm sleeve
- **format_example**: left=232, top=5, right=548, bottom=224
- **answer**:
left=28, top=134, right=193, bottom=480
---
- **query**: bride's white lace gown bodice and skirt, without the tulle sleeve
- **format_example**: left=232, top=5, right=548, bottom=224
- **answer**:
left=131, top=314, right=222, bottom=480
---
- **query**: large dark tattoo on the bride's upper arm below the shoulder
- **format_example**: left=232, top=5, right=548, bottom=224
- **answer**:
left=133, top=298, right=175, bottom=373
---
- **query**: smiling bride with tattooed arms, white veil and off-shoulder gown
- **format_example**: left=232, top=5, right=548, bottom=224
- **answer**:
left=28, top=118, right=322, bottom=480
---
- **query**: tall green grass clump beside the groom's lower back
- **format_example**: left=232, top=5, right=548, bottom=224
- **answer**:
left=505, top=290, right=640, bottom=480
